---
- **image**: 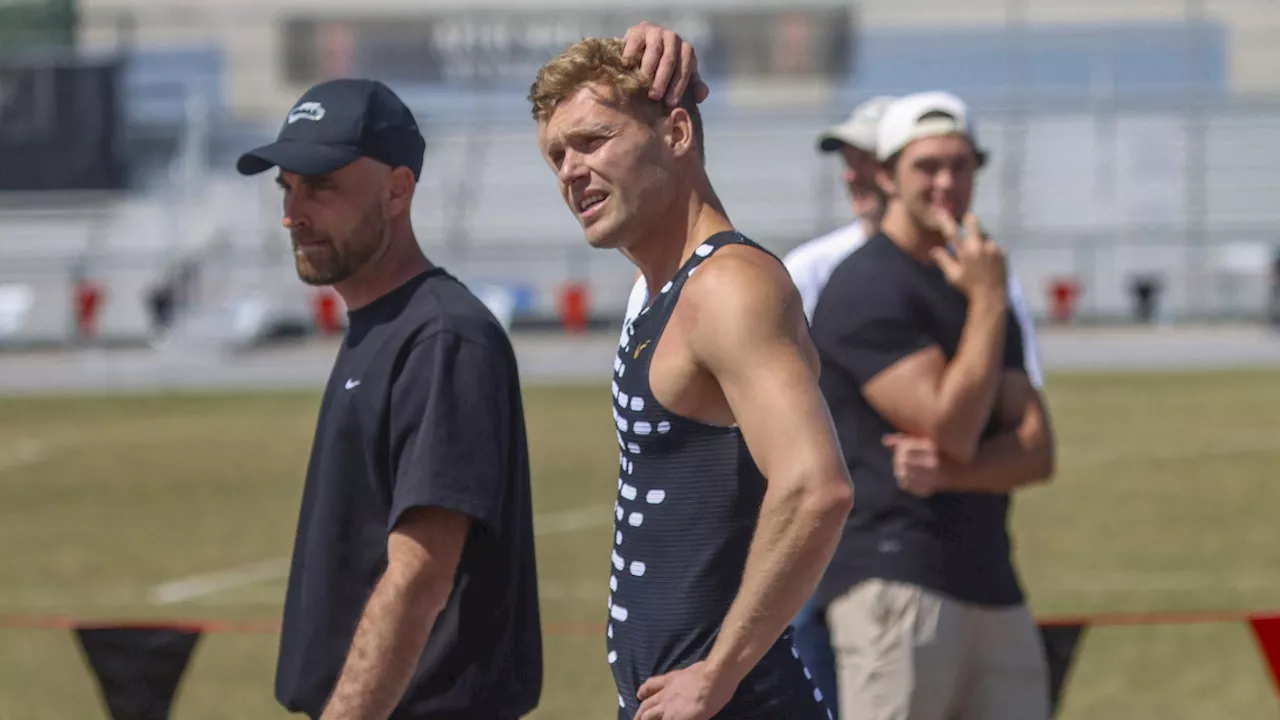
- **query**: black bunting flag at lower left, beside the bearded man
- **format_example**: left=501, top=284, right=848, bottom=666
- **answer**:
left=76, top=628, right=200, bottom=720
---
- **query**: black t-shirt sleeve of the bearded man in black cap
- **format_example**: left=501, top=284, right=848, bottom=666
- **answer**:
left=388, top=331, right=518, bottom=533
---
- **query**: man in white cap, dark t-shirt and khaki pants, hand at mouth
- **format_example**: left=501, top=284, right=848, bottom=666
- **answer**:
left=812, top=92, right=1053, bottom=720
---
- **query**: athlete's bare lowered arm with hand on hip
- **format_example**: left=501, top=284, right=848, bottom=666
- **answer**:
left=637, top=247, right=854, bottom=720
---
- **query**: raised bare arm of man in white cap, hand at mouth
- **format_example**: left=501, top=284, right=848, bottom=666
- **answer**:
left=863, top=210, right=1009, bottom=465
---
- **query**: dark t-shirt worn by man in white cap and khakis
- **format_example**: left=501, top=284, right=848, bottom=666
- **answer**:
left=812, top=233, right=1024, bottom=606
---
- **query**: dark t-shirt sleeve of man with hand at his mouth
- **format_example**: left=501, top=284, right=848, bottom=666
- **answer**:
left=813, top=282, right=937, bottom=387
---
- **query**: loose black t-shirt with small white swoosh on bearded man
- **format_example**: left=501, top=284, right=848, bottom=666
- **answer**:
left=275, top=268, right=543, bottom=720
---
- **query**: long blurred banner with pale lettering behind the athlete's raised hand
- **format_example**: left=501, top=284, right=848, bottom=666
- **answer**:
left=283, top=3, right=854, bottom=87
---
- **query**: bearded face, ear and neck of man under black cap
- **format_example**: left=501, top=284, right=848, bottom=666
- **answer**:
left=275, top=158, right=430, bottom=309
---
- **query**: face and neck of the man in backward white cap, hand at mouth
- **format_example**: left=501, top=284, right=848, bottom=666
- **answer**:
left=877, top=136, right=979, bottom=259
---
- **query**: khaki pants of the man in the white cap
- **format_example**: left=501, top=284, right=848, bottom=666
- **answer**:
left=827, top=580, right=1050, bottom=720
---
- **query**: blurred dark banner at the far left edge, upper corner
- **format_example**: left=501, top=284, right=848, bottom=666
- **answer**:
left=0, top=56, right=125, bottom=191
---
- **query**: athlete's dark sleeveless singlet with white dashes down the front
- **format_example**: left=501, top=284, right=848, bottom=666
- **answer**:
left=607, top=232, right=828, bottom=720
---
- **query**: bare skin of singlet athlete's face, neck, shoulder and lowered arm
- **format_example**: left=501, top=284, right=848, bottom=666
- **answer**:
left=538, top=75, right=852, bottom=720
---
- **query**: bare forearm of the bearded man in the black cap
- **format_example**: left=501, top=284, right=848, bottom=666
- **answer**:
left=321, top=507, right=471, bottom=720
